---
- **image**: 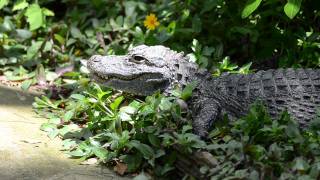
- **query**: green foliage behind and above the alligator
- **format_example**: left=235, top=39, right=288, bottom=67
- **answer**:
left=0, top=0, right=319, bottom=85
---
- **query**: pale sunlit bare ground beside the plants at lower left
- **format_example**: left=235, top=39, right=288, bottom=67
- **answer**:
left=0, top=85, right=124, bottom=180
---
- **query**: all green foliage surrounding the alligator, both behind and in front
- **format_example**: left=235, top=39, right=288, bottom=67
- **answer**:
left=0, top=0, right=320, bottom=179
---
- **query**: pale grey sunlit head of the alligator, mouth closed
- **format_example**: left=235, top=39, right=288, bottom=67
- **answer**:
left=87, top=45, right=195, bottom=96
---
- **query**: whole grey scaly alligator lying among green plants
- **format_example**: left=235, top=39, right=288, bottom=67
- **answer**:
left=87, top=45, right=320, bottom=137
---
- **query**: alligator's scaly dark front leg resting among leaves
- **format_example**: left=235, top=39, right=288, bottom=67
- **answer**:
left=192, top=99, right=221, bottom=138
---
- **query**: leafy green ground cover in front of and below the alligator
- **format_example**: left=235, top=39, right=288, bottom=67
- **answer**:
left=34, top=84, right=320, bottom=179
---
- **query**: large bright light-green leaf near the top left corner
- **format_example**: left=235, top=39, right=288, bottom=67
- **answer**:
left=25, top=4, right=44, bottom=31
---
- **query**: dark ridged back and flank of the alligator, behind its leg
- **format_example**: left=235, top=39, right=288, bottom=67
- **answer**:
left=213, top=69, right=320, bottom=124
